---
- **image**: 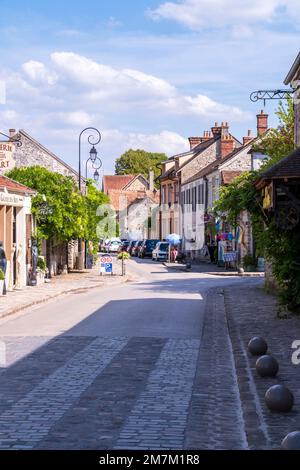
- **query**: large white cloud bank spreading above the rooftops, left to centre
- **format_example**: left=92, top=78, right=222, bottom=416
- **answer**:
left=0, top=52, right=255, bottom=172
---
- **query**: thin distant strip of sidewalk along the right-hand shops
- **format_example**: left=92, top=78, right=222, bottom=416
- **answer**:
left=163, top=262, right=265, bottom=277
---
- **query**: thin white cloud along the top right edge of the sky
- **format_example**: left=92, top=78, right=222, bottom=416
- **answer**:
left=148, top=0, right=300, bottom=29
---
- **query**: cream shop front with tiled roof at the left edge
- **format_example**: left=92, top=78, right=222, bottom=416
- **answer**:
left=0, top=175, right=35, bottom=291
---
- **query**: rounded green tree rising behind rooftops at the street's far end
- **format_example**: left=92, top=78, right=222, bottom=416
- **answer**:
left=115, top=149, right=168, bottom=179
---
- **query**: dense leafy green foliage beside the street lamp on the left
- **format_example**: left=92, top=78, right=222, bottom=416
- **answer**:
left=7, top=166, right=109, bottom=246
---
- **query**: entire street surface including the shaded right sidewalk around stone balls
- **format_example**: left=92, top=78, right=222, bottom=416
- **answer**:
left=0, top=261, right=299, bottom=450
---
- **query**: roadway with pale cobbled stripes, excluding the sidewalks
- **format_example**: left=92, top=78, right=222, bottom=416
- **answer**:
left=0, top=260, right=258, bottom=449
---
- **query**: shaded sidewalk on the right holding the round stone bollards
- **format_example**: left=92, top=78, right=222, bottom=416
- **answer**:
left=224, top=286, right=300, bottom=449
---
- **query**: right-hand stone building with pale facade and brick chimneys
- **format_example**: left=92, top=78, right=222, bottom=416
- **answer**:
left=181, top=111, right=268, bottom=257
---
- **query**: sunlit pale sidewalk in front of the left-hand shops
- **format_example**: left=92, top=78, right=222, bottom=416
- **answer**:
left=0, top=261, right=128, bottom=318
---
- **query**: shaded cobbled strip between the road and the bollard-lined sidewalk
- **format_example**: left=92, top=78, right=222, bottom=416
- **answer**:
left=185, top=287, right=249, bottom=450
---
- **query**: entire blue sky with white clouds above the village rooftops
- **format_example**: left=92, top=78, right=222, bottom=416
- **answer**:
left=0, top=0, right=300, bottom=173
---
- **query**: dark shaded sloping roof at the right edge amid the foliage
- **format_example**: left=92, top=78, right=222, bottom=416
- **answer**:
left=258, top=147, right=300, bottom=181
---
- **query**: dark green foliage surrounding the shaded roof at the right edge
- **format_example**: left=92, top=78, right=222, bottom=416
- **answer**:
left=214, top=100, right=300, bottom=311
